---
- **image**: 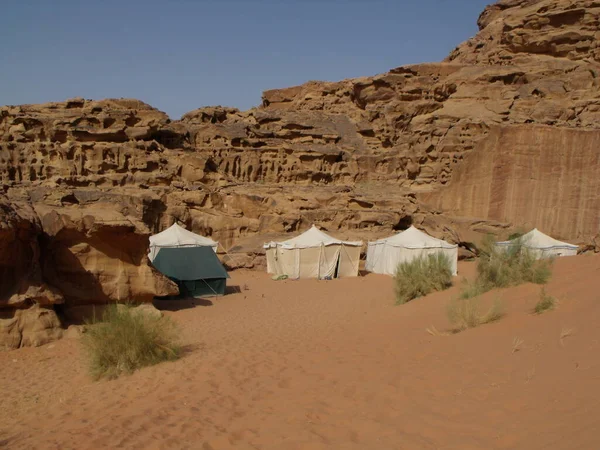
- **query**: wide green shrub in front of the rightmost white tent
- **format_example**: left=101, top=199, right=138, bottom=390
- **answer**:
left=461, top=236, right=552, bottom=299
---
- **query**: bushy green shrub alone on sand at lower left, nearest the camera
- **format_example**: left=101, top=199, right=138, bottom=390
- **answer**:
left=82, top=304, right=180, bottom=379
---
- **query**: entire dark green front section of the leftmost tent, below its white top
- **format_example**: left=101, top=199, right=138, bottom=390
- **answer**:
left=153, top=247, right=229, bottom=298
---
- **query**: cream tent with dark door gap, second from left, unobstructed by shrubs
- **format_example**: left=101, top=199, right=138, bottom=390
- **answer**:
left=263, top=225, right=362, bottom=279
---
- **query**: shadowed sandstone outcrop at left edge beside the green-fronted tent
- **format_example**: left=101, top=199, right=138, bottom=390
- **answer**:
left=0, top=188, right=178, bottom=348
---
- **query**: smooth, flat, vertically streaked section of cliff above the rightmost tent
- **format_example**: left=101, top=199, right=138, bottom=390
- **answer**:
left=429, top=126, right=600, bottom=242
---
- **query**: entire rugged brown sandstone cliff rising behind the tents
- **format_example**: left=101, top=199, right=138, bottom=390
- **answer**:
left=0, top=0, right=600, bottom=345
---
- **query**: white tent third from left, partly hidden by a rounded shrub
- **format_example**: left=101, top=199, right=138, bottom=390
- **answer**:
left=365, top=226, right=458, bottom=275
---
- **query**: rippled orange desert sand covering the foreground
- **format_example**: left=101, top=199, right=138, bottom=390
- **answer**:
left=0, top=256, right=600, bottom=450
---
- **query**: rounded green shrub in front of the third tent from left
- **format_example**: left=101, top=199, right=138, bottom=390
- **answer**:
left=395, top=252, right=452, bottom=305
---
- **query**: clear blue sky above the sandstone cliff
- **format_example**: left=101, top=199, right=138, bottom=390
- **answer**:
left=0, top=0, right=491, bottom=119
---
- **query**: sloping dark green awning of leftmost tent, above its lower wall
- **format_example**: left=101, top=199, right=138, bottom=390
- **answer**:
left=153, top=247, right=229, bottom=281
